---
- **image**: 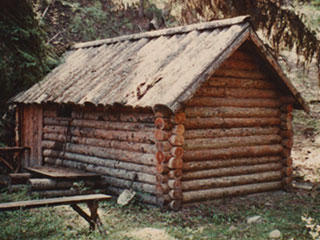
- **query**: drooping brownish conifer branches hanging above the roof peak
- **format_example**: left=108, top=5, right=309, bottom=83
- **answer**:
left=171, top=0, right=320, bottom=79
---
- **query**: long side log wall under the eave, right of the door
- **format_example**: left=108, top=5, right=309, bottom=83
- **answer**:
left=42, top=106, right=157, bottom=204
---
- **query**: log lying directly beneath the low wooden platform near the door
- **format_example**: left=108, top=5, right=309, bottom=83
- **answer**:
left=28, top=178, right=98, bottom=191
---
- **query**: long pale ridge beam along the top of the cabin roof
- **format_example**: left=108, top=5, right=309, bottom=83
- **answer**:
left=71, top=15, right=250, bottom=49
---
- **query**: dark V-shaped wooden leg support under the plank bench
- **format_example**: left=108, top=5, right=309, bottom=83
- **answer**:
left=71, top=201, right=104, bottom=234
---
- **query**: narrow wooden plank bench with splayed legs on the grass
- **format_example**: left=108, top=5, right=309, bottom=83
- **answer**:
left=0, top=194, right=111, bottom=233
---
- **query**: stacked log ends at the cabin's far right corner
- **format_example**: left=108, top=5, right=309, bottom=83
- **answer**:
left=280, top=97, right=294, bottom=189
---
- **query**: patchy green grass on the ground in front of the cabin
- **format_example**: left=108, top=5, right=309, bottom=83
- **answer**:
left=0, top=192, right=320, bottom=240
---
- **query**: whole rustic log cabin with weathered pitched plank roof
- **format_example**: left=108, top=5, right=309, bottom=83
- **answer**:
left=11, top=16, right=309, bottom=210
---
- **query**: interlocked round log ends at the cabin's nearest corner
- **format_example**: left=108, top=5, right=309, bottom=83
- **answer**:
left=155, top=112, right=185, bottom=210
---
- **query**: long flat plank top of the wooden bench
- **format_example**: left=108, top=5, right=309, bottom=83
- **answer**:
left=0, top=194, right=112, bottom=211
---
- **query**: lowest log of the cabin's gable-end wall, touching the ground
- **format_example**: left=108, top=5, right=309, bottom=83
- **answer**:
left=182, top=181, right=282, bottom=203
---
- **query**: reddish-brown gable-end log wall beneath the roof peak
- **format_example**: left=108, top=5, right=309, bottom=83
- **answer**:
left=181, top=50, right=292, bottom=205
